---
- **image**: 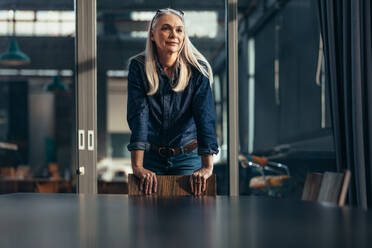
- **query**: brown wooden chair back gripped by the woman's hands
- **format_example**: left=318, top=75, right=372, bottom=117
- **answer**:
left=128, top=174, right=217, bottom=197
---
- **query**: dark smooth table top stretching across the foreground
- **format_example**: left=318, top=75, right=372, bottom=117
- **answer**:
left=0, top=193, right=372, bottom=248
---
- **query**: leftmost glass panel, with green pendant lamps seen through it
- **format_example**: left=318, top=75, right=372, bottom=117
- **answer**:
left=0, top=4, right=76, bottom=194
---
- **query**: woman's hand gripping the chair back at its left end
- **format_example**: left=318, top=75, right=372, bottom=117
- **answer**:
left=132, top=167, right=158, bottom=195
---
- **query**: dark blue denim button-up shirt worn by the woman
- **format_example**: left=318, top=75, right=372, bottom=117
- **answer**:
left=127, top=55, right=218, bottom=155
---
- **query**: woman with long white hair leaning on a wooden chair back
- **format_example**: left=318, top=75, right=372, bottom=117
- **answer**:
left=127, top=8, right=218, bottom=195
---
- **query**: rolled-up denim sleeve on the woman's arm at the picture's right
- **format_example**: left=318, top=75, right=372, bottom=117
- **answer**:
left=192, top=76, right=218, bottom=155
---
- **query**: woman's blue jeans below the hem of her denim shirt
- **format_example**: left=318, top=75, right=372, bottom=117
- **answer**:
left=143, top=148, right=202, bottom=175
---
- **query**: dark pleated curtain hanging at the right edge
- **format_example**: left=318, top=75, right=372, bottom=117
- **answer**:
left=318, top=0, right=372, bottom=209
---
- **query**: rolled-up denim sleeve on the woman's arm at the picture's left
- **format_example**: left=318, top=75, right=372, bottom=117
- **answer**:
left=127, top=60, right=149, bottom=151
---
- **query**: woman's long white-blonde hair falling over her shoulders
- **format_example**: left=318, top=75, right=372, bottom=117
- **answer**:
left=131, top=8, right=213, bottom=95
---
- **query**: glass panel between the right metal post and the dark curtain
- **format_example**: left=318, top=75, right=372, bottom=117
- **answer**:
left=239, top=0, right=336, bottom=198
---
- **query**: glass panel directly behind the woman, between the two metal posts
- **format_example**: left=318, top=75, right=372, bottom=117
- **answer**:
left=97, top=1, right=228, bottom=194
